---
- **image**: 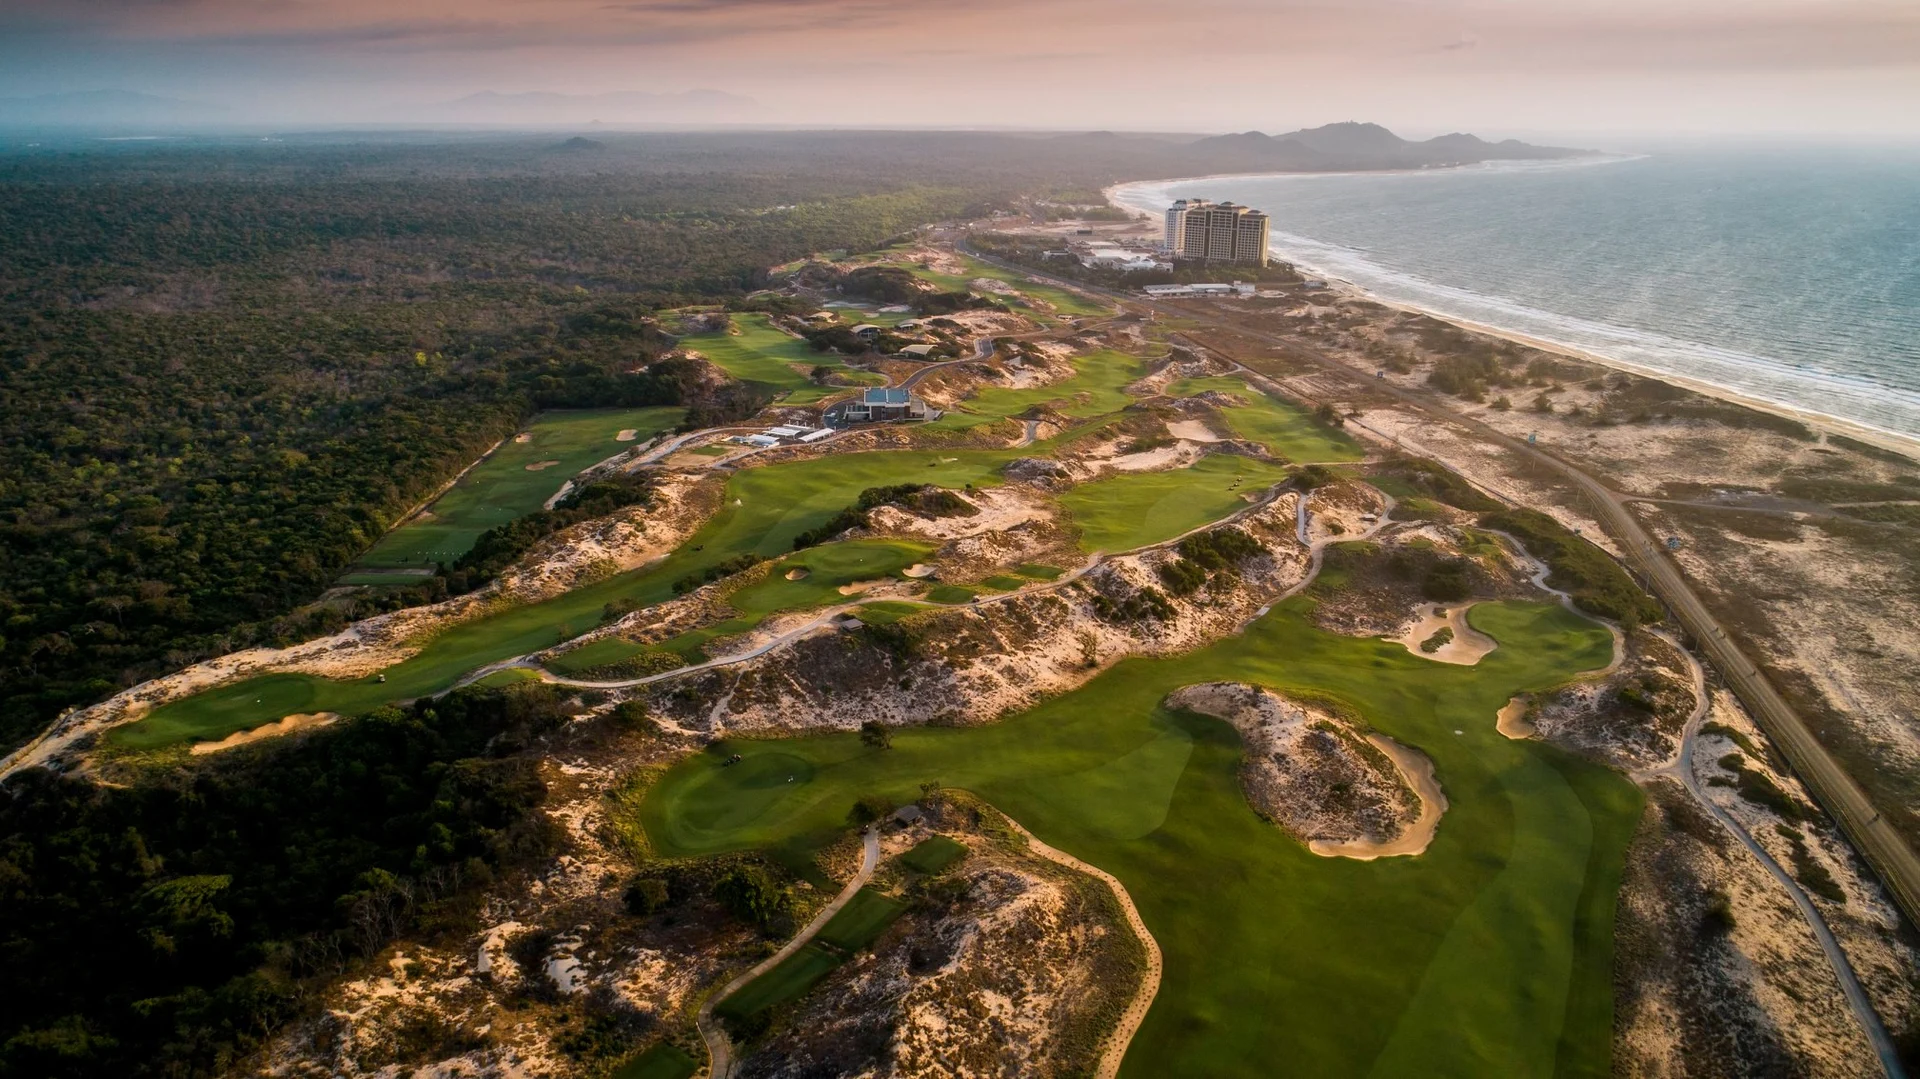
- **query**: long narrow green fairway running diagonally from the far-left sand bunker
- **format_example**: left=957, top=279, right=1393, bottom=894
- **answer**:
left=120, top=449, right=1020, bottom=749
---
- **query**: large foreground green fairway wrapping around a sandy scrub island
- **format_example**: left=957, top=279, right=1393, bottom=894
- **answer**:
left=639, top=599, right=1640, bottom=1079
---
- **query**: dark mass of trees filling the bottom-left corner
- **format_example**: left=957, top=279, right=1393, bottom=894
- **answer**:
left=0, top=685, right=566, bottom=1079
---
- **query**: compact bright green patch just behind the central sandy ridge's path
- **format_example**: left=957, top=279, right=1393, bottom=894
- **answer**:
left=1060, top=453, right=1286, bottom=551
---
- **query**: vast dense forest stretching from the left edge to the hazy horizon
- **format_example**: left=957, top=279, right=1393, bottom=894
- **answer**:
left=0, top=134, right=1119, bottom=751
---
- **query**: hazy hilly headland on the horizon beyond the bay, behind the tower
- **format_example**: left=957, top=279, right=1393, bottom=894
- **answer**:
left=1185, top=121, right=1592, bottom=171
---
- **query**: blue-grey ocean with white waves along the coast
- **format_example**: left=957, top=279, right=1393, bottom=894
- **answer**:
left=1116, top=150, right=1920, bottom=438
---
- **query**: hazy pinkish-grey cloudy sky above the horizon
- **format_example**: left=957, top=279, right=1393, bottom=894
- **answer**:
left=0, top=0, right=1920, bottom=140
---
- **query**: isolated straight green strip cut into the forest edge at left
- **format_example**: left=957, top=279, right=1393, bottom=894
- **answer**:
left=353, top=409, right=685, bottom=572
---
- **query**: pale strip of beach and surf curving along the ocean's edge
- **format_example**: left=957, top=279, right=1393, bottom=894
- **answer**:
left=1100, top=176, right=1920, bottom=461
